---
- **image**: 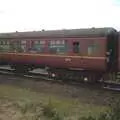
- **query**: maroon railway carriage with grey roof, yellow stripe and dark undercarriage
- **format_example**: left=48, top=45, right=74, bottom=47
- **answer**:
left=0, top=27, right=120, bottom=82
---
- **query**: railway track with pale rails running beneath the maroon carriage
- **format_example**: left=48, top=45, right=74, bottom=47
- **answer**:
left=0, top=68, right=120, bottom=91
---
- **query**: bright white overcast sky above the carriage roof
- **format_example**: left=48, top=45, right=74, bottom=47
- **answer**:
left=0, top=0, right=120, bottom=32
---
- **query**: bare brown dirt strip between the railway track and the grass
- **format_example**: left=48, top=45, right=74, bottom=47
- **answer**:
left=0, top=75, right=120, bottom=105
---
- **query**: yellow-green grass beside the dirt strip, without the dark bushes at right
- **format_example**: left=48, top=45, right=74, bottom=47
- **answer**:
left=0, top=85, right=107, bottom=120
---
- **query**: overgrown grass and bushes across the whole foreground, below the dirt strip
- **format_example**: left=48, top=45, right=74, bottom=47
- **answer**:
left=0, top=85, right=120, bottom=120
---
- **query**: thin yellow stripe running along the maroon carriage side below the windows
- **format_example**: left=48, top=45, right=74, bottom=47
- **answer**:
left=2, top=53, right=106, bottom=62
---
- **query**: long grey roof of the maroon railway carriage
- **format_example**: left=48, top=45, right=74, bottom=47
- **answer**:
left=0, top=27, right=116, bottom=38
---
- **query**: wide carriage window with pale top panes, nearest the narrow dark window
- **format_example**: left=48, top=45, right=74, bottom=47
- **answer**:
left=49, top=40, right=67, bottom=54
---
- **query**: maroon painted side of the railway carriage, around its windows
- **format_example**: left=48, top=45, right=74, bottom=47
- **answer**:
left=0, top=37, right=107, bottom=71
